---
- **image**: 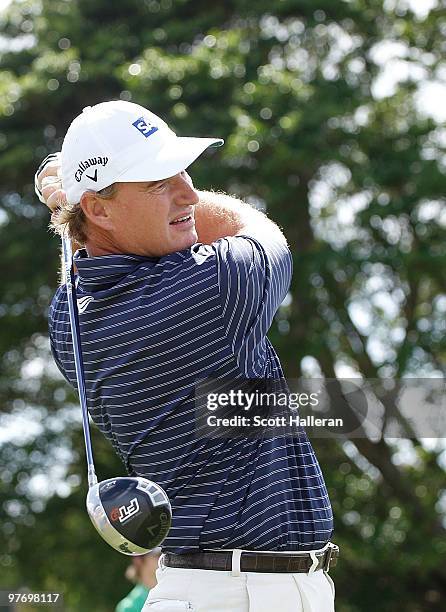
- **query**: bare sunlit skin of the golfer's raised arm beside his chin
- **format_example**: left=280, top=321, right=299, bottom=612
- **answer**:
left=195, top=191, right=287, bottom=245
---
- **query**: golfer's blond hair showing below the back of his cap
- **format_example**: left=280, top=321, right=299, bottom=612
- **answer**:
left=50, top=183, right=117, bottom=246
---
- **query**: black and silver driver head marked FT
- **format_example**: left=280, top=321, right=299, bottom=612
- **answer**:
left=87, top=476, right=172, bottom=555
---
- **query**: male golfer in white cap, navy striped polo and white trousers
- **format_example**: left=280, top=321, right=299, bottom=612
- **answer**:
left=36, top=101, right=338, bottom=612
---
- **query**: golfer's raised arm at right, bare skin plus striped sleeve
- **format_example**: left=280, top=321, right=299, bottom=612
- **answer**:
left=191, top=192, right=293, bottom=378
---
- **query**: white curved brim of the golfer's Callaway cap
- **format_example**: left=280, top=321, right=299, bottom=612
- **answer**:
left=115, top=136, right=224, bottom=183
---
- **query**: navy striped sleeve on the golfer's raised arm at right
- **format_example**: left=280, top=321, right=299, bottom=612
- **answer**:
left=193, top=235, right=293, bottom=377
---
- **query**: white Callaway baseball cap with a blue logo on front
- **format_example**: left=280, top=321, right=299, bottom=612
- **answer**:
left=61, top=100, right=223, bottom=204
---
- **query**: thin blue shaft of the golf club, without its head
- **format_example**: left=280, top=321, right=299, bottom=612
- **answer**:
left=62, top=234, right=98, bottom=487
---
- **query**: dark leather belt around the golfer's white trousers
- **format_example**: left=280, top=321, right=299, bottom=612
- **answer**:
left=162, top=542, right=339, bottom=574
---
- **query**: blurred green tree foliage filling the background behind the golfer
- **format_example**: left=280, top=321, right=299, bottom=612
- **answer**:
left=0, top=0, right=446, bottom=612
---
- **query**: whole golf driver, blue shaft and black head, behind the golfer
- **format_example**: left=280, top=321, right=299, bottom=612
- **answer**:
left=62, top=235, right=172, bottom=555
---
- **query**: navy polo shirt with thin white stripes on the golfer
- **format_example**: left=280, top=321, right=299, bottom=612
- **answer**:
left=49, top=236, right=333, bottom=553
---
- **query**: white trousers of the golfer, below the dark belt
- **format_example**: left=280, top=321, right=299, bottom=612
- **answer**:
left=143, top=551, right=334, bottom=612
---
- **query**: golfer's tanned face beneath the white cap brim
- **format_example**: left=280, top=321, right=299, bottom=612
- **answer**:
left=95, top=171, right=199, bottom=257
